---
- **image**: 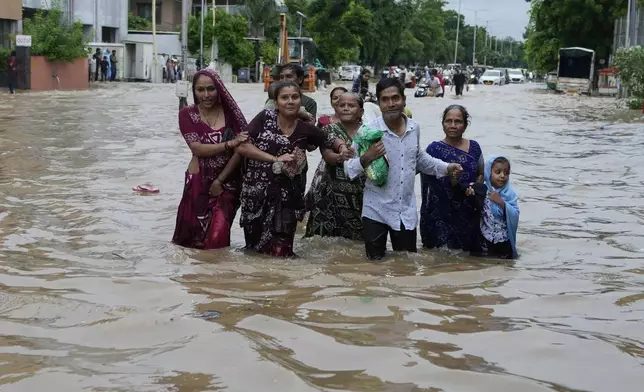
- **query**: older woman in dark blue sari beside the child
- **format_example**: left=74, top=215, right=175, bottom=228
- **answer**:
left=420, top=105, right=484, bottom=252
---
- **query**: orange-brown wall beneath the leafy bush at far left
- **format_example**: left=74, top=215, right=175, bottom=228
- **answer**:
left=31, top=56, right=89, bottom=91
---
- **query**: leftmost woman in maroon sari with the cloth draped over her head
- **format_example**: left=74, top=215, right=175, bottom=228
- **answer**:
left=172, top=69, right=248, bottom=249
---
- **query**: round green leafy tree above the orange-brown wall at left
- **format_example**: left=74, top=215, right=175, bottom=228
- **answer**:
left=23, top=6, right=88, bottom=61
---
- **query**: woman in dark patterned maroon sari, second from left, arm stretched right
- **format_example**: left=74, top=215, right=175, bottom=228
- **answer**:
left=237, top=82, right=353, bottom=257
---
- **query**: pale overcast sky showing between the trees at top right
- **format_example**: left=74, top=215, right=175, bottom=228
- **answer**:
left=447, top=0, right=530, bottom=40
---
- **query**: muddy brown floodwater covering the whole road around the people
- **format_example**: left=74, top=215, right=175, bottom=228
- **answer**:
left=0, top=84, right=644, bottom=392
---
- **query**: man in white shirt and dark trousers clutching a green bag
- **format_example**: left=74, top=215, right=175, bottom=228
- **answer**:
left=345, top=79, right=463, bottom=260
